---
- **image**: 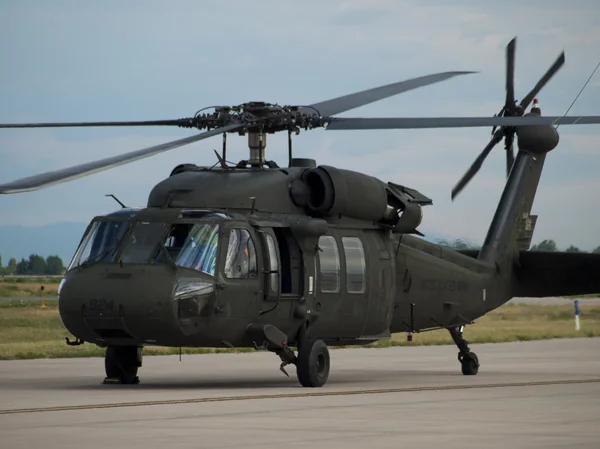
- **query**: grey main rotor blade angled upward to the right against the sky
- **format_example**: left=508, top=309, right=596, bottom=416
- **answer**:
left=300, top=72, right=477, bottom=117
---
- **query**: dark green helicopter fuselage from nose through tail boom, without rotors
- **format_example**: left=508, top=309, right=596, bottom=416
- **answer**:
left=59, top=164, right=509, bottom=347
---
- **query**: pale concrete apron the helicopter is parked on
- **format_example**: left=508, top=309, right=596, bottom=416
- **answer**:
left=0, top=339, right=600, bottom=449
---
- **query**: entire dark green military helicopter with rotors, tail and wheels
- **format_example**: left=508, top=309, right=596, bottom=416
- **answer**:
left=0, top=38, right=600, bottom=387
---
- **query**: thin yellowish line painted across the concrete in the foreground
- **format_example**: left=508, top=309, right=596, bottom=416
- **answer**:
left=0, top=379, right=600, bottom=415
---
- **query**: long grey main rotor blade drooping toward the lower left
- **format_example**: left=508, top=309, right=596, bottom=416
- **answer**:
left=0, top=123, right=241, bottom=194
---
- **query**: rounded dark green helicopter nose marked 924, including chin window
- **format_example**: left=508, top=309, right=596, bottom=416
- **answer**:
left=59, top=266, right=215, bottom=345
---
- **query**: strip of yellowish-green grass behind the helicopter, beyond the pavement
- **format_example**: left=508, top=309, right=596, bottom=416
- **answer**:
left=0, top=299, right=600, bottom=360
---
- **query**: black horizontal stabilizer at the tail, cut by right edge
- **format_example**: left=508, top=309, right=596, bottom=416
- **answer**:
left=513, top=251, right=600, bottom=298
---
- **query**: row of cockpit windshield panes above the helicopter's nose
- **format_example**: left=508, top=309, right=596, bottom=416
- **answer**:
left=69, top=215, right=220, bottom=276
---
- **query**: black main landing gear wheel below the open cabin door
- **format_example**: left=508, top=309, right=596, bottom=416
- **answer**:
left=296, top=339, right=330, bottom=387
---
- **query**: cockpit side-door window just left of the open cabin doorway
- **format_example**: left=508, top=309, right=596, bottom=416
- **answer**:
left=225, top=229, right=258, bottom=279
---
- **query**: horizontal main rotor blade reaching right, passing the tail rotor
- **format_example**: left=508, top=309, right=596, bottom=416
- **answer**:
left=327, top=115, right=600, bottom=130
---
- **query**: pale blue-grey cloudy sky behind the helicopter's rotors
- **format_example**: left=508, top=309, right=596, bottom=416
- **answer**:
left=0, top=0, right=600, bottom=249
